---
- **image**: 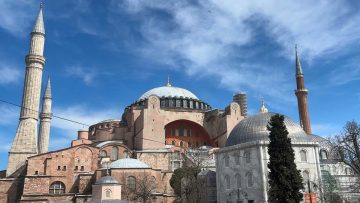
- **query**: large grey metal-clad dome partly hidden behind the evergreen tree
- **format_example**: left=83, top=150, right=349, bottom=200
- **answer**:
left=226, top=112, right=312, bottom=146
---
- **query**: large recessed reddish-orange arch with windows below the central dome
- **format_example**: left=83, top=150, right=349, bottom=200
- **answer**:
left=165, top=119, right=213, bottom=149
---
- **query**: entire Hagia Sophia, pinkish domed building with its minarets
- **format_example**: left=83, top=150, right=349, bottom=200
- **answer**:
left=0, top=3, right=359, bottom=203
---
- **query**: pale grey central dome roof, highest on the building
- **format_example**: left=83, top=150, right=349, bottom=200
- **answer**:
left=138, top=86, right=199, bottom=101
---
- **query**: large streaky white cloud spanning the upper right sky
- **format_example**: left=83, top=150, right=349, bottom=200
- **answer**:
left=111, top=0, right=360, bottom=101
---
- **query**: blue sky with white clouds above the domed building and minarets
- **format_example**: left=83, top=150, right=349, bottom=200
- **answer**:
left=0, top=0, right=360, bottom=169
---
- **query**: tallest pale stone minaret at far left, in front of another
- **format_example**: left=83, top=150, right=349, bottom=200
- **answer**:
left=6, top=6, right=45, bottom=176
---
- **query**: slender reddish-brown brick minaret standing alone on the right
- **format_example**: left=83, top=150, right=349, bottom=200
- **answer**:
left=295, top=46, right=311, bottom=134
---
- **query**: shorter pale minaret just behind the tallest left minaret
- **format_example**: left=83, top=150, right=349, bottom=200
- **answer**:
left=38, top=78, right=52, bottom=154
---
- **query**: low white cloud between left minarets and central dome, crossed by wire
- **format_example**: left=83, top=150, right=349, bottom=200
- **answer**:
left=51, top=105, right=121, bottom=138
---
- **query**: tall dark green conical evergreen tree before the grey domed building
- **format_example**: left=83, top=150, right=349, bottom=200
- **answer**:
left=267, top=114, right=304, bottom=203
